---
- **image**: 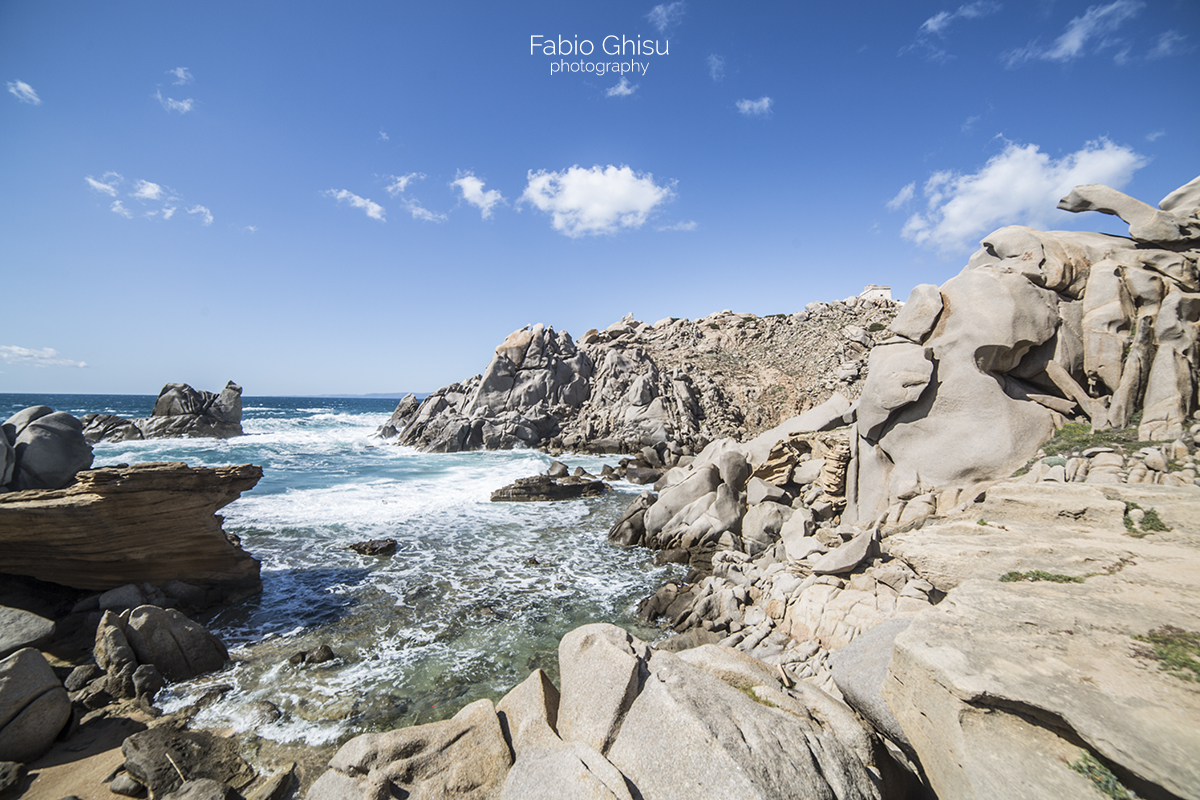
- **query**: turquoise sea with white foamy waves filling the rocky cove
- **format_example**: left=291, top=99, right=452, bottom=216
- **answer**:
left=0, top=395, right=682, bottom=746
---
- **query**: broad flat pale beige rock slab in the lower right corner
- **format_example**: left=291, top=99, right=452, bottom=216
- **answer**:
left=882, top=486, right=1200, bottom=800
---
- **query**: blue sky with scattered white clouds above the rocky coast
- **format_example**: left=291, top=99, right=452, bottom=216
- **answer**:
left=0, top=0, right=1200, bottom=396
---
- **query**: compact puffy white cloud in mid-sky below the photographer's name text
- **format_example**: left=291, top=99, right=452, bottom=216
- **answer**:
left=521, top=164, right=674, bottom=239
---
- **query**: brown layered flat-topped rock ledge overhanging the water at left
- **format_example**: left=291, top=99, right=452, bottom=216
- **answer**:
left=0, top=463, right=263, bottom=602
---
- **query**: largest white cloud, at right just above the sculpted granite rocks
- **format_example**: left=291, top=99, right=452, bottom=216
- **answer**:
left=889, top=139, right=1146, bottom=251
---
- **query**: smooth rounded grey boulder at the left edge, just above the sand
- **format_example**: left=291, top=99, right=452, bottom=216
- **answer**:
left=0, top=648, right=71, bottom=764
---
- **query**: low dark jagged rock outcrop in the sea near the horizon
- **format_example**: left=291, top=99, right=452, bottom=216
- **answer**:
left=82, top=380, right=242, bottom=444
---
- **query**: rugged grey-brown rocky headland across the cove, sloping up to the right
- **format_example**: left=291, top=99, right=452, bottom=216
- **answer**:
left=382, top=297, right=899, bottom=456
